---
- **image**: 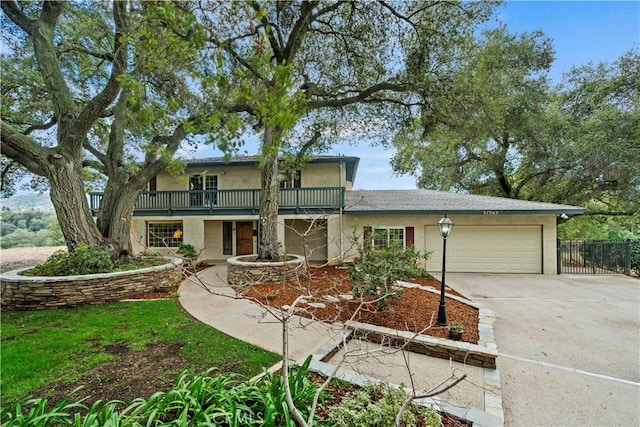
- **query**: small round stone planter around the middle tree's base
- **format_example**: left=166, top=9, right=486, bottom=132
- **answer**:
left=227, top=254, right=307, bottom=286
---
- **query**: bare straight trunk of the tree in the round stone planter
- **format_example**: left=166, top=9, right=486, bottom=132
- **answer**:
left=258, top=126, right=280, bottom=261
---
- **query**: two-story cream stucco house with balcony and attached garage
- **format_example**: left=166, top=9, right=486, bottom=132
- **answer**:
left=90, top=156, right=583, bottom=274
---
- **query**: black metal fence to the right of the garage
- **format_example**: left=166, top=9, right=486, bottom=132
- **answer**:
left=558, top=240, right=632, bottom=275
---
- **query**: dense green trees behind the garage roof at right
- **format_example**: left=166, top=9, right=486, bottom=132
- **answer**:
left=392, top=24, right=640, bottom=213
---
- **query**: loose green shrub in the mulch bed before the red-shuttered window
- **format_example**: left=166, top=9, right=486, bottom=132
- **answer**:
left=349, top=241, right=429, bottom=305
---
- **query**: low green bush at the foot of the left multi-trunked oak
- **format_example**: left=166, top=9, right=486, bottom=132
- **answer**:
left=24, top=243, right=113, bottom=276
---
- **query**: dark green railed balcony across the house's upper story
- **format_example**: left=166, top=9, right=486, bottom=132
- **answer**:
left=89, top=187, right=344, bottom=216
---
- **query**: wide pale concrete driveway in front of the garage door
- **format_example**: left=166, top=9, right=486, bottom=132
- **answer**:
left=447, top=273, right=640, bottom=427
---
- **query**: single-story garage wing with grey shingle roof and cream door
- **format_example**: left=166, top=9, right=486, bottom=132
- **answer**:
left=343, top=190, right=584, bottom=274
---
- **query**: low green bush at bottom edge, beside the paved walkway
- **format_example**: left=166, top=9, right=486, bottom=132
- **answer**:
left=328, top=384, right=442, bottom=427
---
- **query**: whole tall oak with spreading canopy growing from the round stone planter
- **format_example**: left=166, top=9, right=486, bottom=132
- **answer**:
left=196, top=0, right=494, bottom=259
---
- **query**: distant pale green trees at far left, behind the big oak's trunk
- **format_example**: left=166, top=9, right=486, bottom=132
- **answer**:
left=0, top=208, right=64, bottom=249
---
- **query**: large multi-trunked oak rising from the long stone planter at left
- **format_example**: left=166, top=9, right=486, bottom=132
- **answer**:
left=1, top=1, right=233, bottom=256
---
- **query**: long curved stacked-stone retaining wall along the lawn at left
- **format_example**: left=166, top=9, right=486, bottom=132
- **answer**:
left=0, top=258, right=182, bottom=310
